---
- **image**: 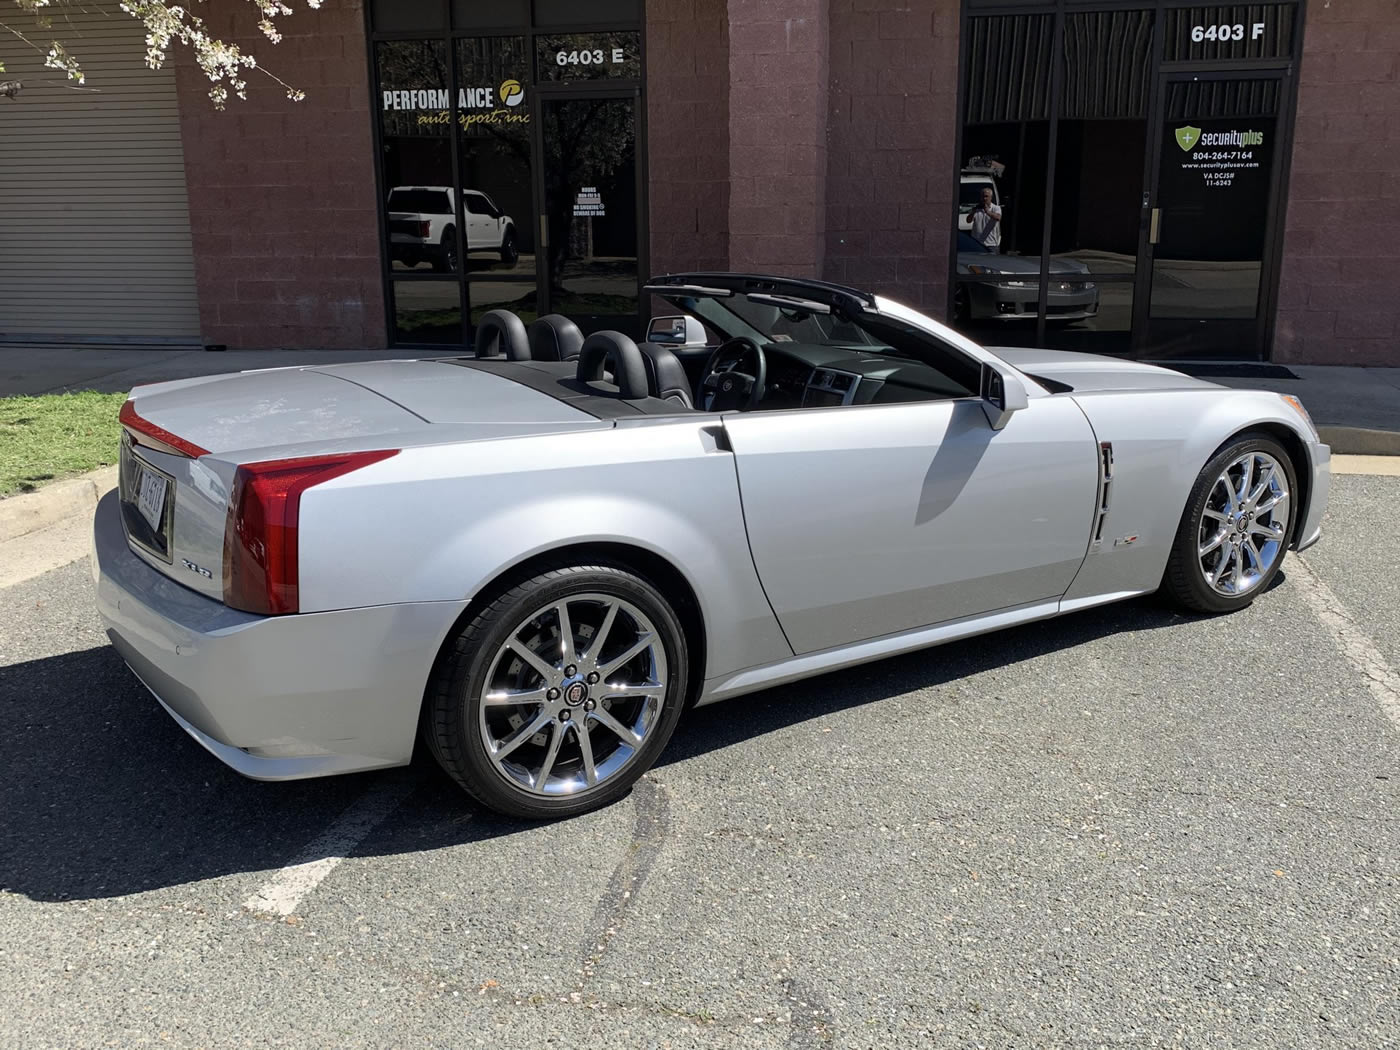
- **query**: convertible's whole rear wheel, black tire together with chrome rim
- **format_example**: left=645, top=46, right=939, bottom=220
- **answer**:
left=421, top=563, right=689, bottom=819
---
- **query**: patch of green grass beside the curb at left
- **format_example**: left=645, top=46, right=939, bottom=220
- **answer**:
left=0, top=391, right=126, bottom=496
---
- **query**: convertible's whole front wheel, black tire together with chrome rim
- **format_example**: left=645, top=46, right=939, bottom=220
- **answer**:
left=1162, top=434, right=1296, bottom=613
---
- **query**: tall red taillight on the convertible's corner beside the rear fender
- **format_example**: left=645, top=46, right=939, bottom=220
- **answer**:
left=224, top=449, right=398, bottom=616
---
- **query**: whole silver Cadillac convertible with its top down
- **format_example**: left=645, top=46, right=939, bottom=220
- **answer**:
left=92, top=273, right=1330, bottom=818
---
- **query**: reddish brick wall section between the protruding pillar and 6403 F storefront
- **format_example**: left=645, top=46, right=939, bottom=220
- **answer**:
left=825, top=0, right=959, bottom=316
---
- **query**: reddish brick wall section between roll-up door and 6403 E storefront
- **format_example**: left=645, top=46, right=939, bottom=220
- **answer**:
left=176, top=0, right=385, bottom=349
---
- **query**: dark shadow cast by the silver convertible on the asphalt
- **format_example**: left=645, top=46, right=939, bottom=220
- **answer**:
left=0, top=599, right=1204, bottom=900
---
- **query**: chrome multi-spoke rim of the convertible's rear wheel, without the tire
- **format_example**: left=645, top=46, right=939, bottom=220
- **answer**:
left=479, top=594, right=669, bottom=797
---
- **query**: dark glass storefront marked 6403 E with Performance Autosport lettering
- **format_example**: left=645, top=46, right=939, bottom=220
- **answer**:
left=370, top=0, right=645, bottom=343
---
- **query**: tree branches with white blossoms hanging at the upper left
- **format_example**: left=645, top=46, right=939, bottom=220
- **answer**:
left=0, top=0, right=322, bottom=109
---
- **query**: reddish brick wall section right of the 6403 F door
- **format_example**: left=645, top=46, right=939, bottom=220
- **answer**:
left=1273, top=0, right=1400, bottom=365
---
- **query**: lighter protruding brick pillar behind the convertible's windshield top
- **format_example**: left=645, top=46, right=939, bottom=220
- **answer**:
left=728, top=0, right=829, bottom=277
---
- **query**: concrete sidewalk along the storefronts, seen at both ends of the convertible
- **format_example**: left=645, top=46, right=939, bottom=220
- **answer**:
left=0, top=347, right=1400, bottom=455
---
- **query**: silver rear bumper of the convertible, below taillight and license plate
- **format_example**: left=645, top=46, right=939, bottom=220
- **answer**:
left=92, top=493, right=466, bottom=780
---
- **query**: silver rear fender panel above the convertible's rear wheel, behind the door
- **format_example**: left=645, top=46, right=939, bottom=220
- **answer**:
left=300, top=421, right=791, bottom=675
